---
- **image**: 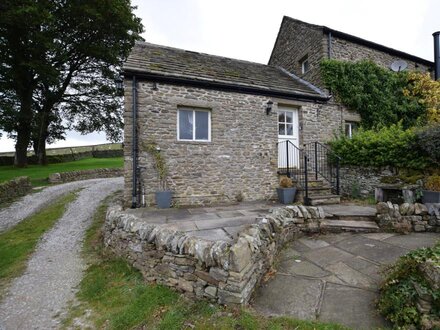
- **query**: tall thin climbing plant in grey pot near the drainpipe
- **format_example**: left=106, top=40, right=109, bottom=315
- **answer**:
left=145, top=142, right=173, bottom=209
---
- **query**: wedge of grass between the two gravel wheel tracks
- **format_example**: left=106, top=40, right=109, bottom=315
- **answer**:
left=0, top=192, right=76, bottom=297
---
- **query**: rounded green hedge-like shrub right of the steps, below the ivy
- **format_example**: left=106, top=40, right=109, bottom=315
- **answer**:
left=330, top=124, right=430, bottom=169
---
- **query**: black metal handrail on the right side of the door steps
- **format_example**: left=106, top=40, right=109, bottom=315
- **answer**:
left=304, top=141, right=341, bottom=195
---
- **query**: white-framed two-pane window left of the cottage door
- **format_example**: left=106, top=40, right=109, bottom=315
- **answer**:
left=177, top=107, right=211, bottom=142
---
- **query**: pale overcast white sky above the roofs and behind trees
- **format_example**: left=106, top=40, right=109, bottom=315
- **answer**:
left=0, top=0, right=440, bottom=152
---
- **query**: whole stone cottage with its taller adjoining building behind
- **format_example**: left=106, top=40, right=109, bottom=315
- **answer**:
left=124, top=17, right=433, bottom=207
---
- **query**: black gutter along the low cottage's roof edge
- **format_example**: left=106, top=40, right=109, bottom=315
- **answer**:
left=124, top=68, right=329, bottom=102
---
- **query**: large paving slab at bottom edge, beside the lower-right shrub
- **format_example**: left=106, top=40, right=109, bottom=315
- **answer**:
left=319, top=283, right=388, bottom=329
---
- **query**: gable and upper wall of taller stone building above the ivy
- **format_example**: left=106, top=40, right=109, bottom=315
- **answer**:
left=269, top=16, right=434, bottom=87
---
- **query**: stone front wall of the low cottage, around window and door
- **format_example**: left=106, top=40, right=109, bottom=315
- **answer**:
left=124, top=81, right=355, bottom=205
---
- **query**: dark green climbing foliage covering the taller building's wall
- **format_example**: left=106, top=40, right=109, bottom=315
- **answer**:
left=321, top=60, right=426, bottom=128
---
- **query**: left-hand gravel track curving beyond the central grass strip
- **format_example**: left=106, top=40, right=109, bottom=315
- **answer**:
left=0, top=179, right=117, bottom=233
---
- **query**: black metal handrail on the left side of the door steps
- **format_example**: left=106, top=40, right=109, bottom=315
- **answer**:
left=277, top=140, right=310, bottom=205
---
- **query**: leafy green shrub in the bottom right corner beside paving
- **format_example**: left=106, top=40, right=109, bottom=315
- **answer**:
left=377, top=243, right=440, bottom=329
